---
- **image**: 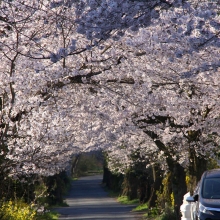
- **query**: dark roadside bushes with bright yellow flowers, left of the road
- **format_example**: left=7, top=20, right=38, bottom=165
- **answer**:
left=0, top=172, right=70, bottom=220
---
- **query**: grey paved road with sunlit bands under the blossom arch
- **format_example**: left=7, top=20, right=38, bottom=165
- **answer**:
left=56, top=175, right=144, bottom=220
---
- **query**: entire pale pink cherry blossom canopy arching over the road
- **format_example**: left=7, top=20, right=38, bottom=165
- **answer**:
left=0, top=0, right=220, bottom=176
